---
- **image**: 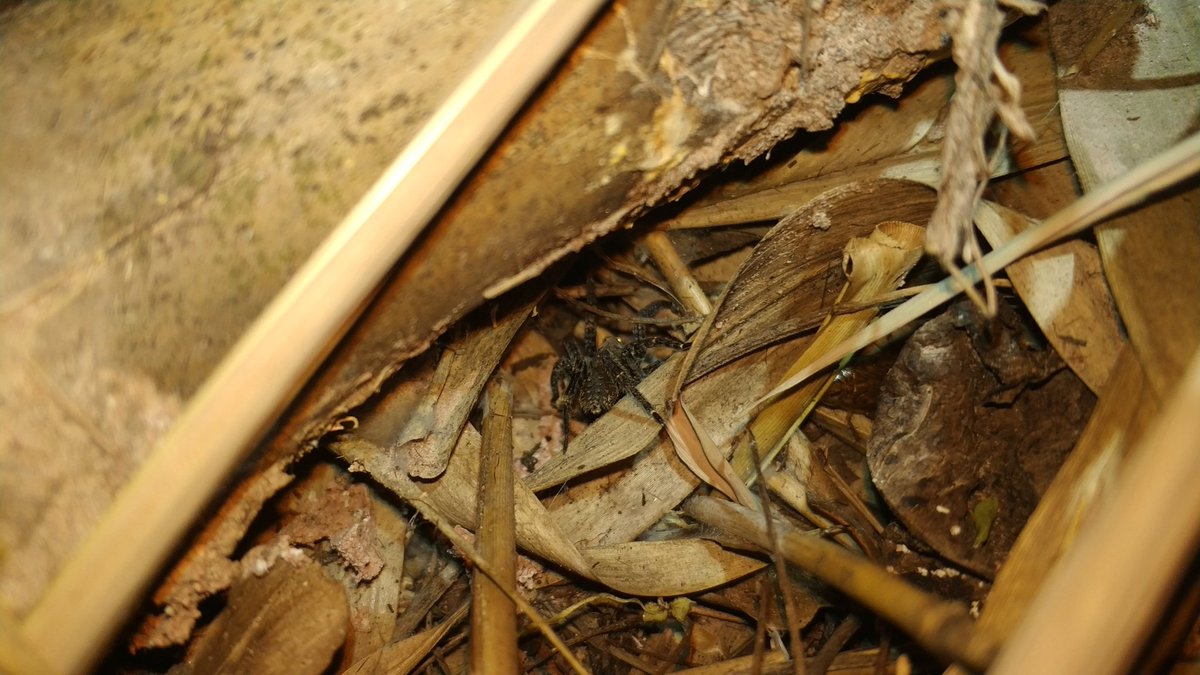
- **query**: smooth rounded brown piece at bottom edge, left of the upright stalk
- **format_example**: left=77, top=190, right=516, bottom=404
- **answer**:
left=173, top=557, right=349, bottom=675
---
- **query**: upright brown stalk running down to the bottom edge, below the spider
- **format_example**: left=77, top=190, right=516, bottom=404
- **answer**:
left=470, top=377, right=520, bottom=674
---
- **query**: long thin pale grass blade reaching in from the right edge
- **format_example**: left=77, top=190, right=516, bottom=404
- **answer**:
left=758, top=133, right=1200, bottom=404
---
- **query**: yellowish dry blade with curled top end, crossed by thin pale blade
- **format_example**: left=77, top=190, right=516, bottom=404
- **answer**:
left=731, top=221, right=925, bottom=483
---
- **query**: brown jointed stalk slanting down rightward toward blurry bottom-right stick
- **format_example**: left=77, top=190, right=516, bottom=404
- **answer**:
left=688, top=497, right=998, bottom=670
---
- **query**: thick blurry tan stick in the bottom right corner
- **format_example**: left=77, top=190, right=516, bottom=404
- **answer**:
left=994, top=351, right=1200, bottom=675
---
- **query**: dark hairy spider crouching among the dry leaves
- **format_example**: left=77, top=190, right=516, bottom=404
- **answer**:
left=550, top=296, right=684, bottom=450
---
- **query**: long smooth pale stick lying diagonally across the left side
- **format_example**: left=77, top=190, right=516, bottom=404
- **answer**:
left=24, top=0, right=601, bottom=674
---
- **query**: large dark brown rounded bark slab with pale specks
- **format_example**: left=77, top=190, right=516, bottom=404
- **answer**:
left=868, top=301, right=1094, bottom=571
